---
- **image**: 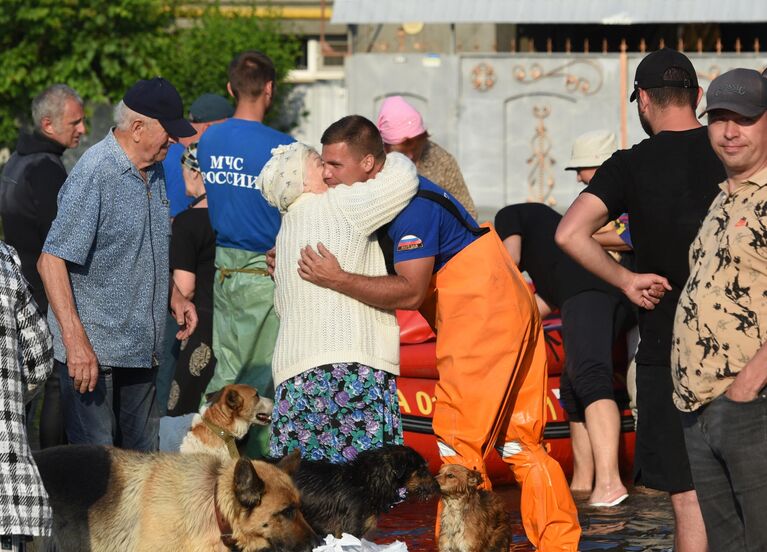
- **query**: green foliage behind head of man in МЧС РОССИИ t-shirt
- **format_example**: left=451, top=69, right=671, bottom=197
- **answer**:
left=161, top=2, right=300, bottom=130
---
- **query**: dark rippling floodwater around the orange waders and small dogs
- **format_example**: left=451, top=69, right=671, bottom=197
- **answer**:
left=376, top=486, right=674, bottom=552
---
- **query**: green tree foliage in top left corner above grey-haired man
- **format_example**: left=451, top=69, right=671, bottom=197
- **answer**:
left=0, top=0, right=173, bottom=145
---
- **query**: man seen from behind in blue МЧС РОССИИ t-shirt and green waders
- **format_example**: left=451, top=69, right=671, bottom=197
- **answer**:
left=197, top=51, right=294, bottom=457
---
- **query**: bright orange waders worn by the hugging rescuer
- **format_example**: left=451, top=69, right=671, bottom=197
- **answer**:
left=421, top=224, right=581, bottom=552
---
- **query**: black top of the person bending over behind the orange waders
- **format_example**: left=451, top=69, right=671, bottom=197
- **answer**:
left=495, top=203, right=617, bottom=308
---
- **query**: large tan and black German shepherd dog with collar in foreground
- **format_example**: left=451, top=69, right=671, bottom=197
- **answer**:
left=34, top=445, right=320, bottom=552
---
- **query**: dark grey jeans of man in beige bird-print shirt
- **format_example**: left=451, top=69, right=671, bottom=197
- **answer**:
left=682, top=390, right=767, bottom=552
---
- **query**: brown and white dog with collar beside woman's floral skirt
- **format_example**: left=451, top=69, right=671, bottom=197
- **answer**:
left=179, top=383, right=274, bottom=460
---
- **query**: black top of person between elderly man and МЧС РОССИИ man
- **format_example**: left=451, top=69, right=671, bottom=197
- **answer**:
left=170, top=208, right=216, bottom=310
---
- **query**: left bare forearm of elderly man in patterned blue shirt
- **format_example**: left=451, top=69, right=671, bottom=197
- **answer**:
left=37, top=253, right=85, bottom=344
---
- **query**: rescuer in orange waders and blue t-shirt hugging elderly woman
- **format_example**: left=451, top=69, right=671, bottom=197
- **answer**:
left=299, top=116, right=581, bottom=552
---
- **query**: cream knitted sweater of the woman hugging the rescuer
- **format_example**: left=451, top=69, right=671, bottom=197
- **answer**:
left=272, top=149, right=418, bottom=385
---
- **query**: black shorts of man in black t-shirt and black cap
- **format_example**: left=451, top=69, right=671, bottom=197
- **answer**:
left=634, top=364, right=695, bottom=493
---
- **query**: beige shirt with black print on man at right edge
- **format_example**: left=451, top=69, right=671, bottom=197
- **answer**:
left=671, top=170, right=767, bottom=412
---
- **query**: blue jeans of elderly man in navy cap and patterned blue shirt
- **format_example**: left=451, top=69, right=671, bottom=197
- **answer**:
left=56, top=361, right=160, bottom=452
